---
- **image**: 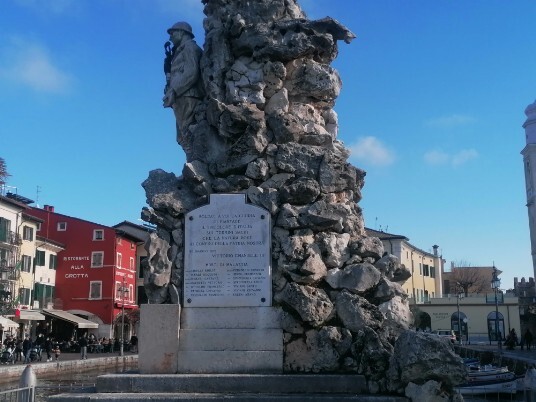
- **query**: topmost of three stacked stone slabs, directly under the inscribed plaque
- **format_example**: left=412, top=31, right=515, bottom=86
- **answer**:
left=180, top=307, right=281, bottom=329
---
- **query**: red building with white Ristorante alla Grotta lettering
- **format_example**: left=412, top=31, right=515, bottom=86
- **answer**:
left=31, top=205, right=139, bottom=340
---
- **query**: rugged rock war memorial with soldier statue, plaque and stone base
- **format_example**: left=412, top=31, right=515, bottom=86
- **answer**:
left=59, top=0, right=465, bottom=401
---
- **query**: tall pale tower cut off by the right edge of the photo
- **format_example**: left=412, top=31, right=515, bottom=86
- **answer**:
left=521, top=102, right=536, bottom=277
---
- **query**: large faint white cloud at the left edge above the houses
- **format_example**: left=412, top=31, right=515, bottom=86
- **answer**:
left=0, top=38, right=73, bottom=93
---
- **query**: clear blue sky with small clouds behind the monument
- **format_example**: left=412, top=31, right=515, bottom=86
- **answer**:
left=0, top=0, right=536, bottom=288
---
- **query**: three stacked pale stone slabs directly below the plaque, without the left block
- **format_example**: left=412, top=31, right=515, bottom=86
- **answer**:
left=177, top=307, right=283, bottom=374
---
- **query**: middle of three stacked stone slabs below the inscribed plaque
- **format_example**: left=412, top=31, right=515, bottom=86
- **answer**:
left=179, top=328, right=283, bottom=351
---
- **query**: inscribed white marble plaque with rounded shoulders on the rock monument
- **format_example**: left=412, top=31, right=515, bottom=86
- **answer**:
left=184, top=194, right=272, bottom=307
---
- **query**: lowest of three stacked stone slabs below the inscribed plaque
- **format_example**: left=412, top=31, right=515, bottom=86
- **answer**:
left=177, top=350, right=283, bottom=374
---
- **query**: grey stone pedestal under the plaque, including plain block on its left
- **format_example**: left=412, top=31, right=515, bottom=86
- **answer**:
left=139, top=304, right=283, bottom=374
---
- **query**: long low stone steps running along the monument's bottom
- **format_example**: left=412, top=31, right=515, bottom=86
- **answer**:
left=48, top=373, right=408, bottom=402
